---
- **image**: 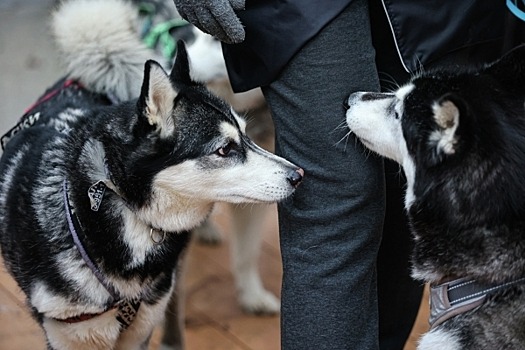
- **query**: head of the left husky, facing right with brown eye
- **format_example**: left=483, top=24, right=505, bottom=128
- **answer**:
left=105, top=42, right=303, bottom=231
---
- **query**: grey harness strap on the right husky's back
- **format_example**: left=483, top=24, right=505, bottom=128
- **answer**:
left=429, top=277, right=525, bottom=329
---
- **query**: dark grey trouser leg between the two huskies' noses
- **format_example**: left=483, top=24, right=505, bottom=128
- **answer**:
left=263, top=0, right=385, bottom=350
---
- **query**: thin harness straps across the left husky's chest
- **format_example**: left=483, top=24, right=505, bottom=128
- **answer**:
left=59, top=180, right=141, bottom=331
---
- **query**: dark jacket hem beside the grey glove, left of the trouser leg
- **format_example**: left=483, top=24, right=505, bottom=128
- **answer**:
left=223, top=0, right=352, bottom=92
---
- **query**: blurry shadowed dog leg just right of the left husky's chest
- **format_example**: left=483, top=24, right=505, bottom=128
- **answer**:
left=159, top=258, right=187, bottom=350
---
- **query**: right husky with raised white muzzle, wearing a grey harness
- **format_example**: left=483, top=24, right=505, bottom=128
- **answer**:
left=346, top=46, right=525, bottom=350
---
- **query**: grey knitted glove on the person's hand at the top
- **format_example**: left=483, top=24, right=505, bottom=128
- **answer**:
left=173, top=0, right=245, bottom=44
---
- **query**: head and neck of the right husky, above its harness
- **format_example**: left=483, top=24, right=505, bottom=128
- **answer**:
left=346, top=46, right=525, bottom=280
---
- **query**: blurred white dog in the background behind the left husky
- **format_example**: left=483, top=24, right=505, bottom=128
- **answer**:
left=133, top=0, right=280, bottom=322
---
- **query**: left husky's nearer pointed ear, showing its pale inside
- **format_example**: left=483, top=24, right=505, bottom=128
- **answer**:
left=137, top=60, right=177, bottom=136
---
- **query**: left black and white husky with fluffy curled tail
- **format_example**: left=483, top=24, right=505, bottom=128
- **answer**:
left=0, top=0, right=303, bottom=350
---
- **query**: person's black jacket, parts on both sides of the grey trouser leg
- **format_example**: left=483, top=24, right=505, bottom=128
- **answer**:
left=223, top=0, right=524, bottom=91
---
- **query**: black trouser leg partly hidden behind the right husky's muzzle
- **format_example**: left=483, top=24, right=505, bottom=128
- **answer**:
left=369, top=0, right=424, bottom=350
